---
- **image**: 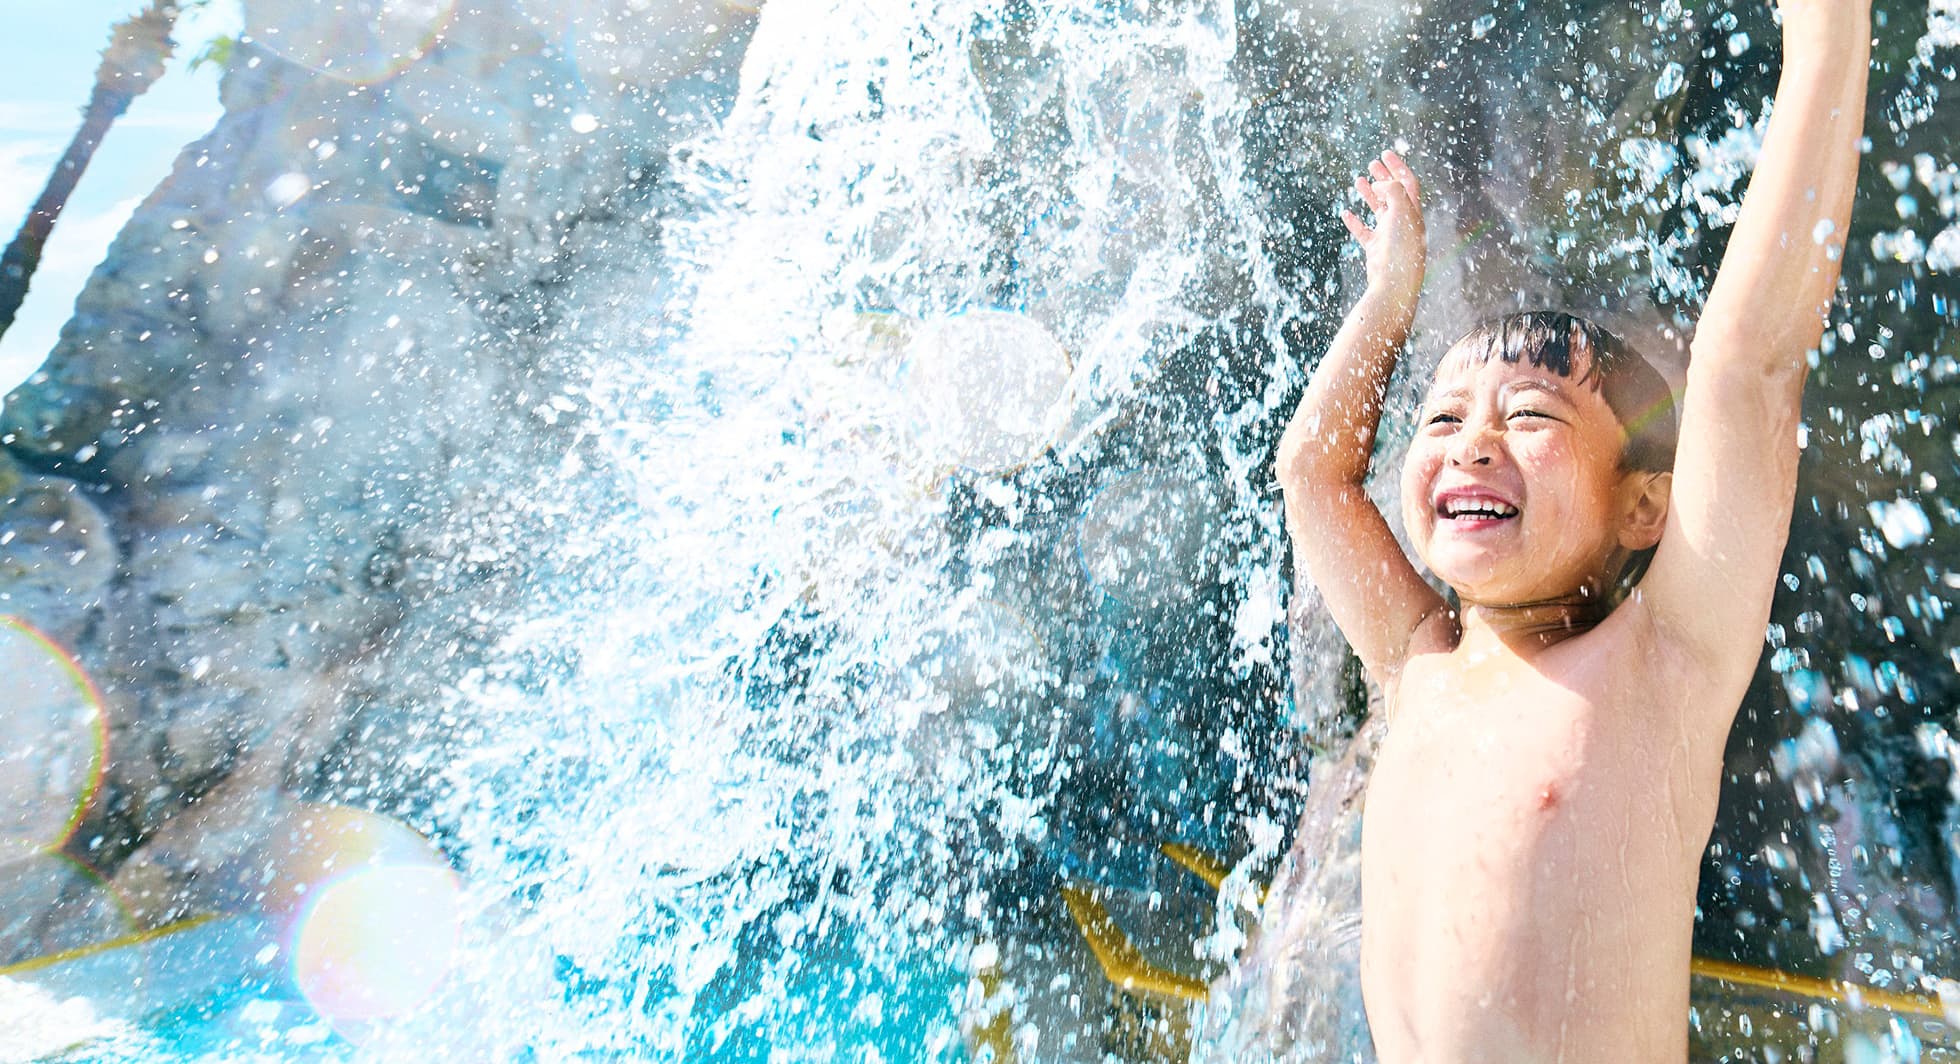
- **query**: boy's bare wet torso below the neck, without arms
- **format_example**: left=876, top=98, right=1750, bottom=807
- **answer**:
left=1362, top=607, right=1742, bottom=1064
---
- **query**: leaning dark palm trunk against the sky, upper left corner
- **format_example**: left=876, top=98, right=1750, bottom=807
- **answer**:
left=0, top=0, right=180, bottom=335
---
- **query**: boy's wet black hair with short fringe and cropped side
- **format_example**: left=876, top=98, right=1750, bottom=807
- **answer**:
left=1445, top=310, right=1678, bottom=472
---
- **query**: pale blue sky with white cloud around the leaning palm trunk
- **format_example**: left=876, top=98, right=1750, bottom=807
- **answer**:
left=0, top=0, right=239, bottom=394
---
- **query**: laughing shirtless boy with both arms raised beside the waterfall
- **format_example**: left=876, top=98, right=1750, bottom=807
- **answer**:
left=1278, top=0, right=1870, bottom=1064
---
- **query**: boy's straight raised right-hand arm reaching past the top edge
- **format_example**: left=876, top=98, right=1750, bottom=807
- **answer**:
left=1641, top=0, right=1872, bottom=709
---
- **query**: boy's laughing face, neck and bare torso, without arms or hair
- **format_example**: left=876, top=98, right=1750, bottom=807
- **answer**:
left=1362, top=359, right=1716, bottom=1064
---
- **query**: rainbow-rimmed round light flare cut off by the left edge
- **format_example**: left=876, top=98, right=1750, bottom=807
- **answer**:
left=0, top=617, right=108, bottom=864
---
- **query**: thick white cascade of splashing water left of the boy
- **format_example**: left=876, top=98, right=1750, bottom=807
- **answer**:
left=403, top=2, right=1301, bottom=1058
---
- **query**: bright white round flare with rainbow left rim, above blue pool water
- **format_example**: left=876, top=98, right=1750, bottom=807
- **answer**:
left=292, top=864, right=463, bottom=1042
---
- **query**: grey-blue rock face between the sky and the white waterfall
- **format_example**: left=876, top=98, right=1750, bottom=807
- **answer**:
left=0, top=0, right=747, bottom=923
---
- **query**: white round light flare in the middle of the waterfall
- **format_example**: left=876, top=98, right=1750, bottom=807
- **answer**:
left=900, top=310, right=1070, bottom=472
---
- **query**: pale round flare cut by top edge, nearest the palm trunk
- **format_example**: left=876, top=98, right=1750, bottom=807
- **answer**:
left=247, top=0, right=457, bottom=84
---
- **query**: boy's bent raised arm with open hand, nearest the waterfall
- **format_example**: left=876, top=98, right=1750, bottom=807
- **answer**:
left=1276, top=151, right=1445, bottom=682
